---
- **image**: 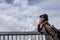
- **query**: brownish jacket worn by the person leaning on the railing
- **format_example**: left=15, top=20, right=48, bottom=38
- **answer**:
left=38, top=23, right=58, bottom=40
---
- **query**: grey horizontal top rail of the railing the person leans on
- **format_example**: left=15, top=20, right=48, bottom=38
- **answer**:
left=0, top=31, right=42, bottom=35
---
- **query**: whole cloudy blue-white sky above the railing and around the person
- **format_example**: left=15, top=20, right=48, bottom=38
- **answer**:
left=0, top=0, right=60, bottom=31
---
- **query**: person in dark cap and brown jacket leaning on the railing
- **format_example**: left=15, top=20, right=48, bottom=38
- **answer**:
left=38, top=14, right=58, bottom=40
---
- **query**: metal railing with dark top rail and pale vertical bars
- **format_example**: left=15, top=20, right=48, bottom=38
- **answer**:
left=0, top=32, right=44, bottom=40
